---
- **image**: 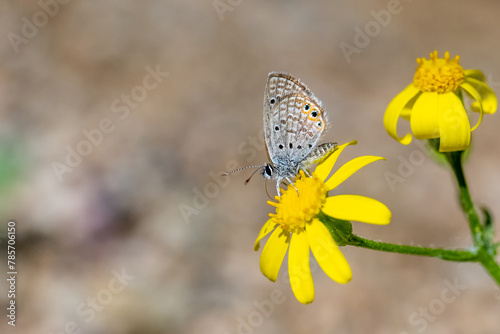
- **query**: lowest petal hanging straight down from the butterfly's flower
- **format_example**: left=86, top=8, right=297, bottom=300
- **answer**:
left=288, top=232, right=314, bottom=304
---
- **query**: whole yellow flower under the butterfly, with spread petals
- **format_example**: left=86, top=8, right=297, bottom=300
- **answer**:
left=254, top=141, right=391, bottom=304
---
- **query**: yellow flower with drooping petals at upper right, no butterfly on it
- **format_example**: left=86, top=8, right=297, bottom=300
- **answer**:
left=384, top=51, right=497, bottom=152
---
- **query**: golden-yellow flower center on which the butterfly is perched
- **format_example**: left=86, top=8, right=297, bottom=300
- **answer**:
left=267, top=171, right=328, bottom=233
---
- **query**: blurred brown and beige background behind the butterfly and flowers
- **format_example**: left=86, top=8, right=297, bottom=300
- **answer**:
left=0, top=0, right=500, bottom=334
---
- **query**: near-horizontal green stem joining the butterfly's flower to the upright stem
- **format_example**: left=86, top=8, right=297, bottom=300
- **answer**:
left=347, top=234, right=479, bottom=262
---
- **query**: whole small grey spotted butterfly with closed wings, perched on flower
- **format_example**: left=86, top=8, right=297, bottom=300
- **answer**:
left=223, top=72, right=337, bottom=195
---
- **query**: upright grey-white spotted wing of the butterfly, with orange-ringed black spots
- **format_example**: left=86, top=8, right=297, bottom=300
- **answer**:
left=264, top=72, right=327, bottom=165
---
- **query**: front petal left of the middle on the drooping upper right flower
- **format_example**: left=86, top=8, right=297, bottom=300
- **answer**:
left=410, top=92, right=440, bottom=139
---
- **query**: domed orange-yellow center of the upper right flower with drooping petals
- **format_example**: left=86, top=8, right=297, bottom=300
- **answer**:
left=413, top=51, right=465, bottom=94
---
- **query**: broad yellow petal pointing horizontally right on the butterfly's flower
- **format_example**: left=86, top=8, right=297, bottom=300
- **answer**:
left=321, top=195, right=392, bottom=225
